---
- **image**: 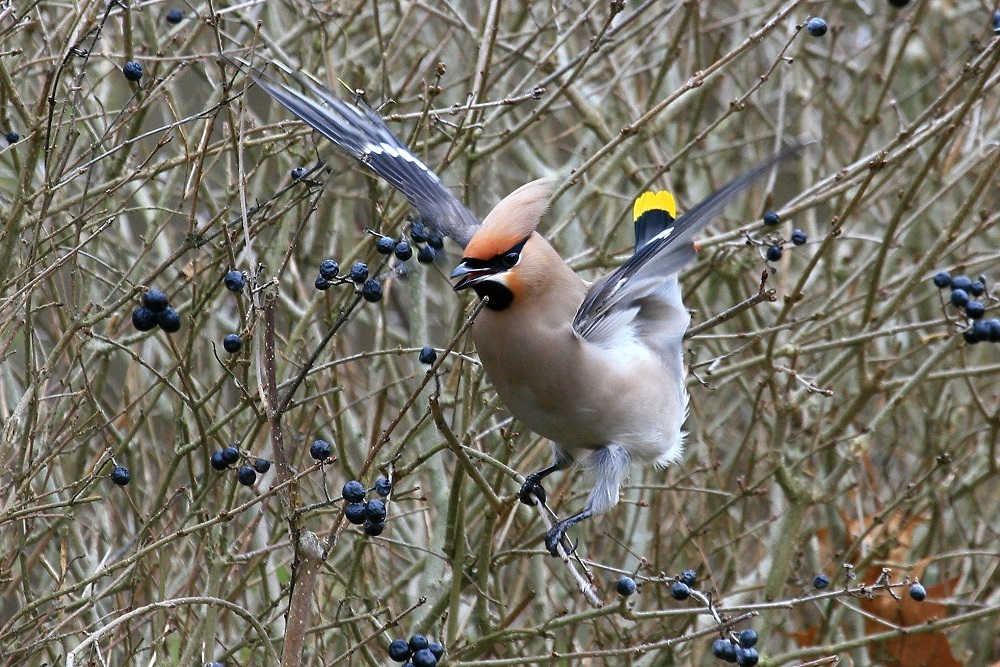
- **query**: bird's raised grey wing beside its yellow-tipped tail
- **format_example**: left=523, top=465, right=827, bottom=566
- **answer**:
left=573, top=145, right=800, bottom=343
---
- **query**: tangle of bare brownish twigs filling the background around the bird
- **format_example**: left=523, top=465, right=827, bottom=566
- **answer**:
left=0, top=0, right=1000, bottom=666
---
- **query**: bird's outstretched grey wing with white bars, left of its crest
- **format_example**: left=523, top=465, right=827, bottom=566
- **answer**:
left=235, top=62, right=479, bottom=248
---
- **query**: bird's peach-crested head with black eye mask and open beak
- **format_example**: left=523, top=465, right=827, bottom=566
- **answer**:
left=451, top=179, right=561, bottom=310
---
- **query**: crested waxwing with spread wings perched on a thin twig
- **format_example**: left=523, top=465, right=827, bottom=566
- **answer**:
left=238, top=62, right=798, bottom=556
